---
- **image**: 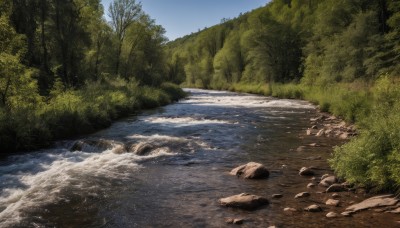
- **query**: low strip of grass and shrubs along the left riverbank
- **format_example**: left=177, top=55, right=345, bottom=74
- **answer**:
left=0, top=79, right=185, bottom=154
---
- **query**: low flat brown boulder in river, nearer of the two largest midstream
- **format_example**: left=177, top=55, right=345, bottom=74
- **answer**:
left=219, top=193, right=269, bottom=210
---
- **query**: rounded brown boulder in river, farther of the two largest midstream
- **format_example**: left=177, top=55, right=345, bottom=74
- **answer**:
left=230, top=162, right=269, bottom=179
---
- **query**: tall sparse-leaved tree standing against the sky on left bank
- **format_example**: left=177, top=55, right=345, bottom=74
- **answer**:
left=108, top=0, right=142, bottom=75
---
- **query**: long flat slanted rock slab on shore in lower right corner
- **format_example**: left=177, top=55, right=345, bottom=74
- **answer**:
left=346, top=195, right=399, bottom=212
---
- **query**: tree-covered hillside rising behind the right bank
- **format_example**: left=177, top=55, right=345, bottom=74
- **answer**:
left=168, top=0, right=400, bottom=88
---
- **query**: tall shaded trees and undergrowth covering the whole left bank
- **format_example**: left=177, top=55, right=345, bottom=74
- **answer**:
left=0, top=0, right=184, bottom=154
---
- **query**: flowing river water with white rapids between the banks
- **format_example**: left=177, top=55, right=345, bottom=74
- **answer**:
left=0, top=89, right=395, bottom=227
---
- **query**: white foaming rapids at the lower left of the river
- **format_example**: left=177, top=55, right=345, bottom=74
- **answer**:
left=0, top=148, right=171, bottom=227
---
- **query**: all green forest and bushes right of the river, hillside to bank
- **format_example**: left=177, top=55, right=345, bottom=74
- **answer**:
left=167, top=0, right=400, bottom=191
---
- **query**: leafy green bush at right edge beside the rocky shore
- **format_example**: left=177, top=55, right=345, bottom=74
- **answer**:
left=330, top=77, right=400, bottom=190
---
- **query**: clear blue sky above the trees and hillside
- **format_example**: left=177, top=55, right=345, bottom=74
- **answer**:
left=101, top=0, right=268, bottom=40
